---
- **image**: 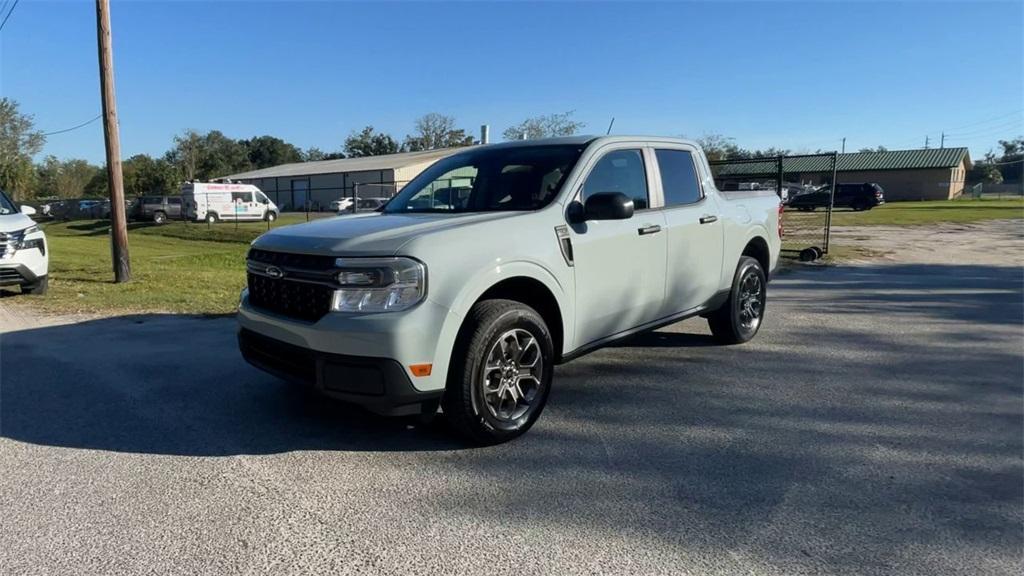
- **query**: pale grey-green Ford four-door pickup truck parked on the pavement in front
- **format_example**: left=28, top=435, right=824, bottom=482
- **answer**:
left=238, top=136, right=780, bottom=444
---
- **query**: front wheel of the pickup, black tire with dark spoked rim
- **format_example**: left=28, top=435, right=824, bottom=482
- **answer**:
left=442, top=299, right=554, bottom=445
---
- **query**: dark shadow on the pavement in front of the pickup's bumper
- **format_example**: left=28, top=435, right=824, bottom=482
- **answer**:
left=0, top=315, right=462, bottom=456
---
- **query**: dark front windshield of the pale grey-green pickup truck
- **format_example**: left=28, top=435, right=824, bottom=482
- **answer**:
left=383, top=145, right=586, bottom=214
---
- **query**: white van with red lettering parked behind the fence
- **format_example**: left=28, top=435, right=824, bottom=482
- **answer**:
left=181, top=182, right=281, bottom=223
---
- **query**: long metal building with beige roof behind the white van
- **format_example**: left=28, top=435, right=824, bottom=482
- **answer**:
left=226, top=149, right=461, bottom=210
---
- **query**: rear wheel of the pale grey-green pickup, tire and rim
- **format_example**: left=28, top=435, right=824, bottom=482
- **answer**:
left=708, top=256, right=768, bottom=344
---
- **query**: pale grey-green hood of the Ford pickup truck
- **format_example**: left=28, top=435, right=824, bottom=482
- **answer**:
left=253, top=212, right=519, bottom=256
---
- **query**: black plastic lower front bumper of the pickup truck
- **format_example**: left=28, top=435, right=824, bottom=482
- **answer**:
left=239, top=328, right=441, bottom=416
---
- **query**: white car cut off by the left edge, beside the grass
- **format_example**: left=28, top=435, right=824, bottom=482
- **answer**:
left=0, top=191, right=49, bottom=294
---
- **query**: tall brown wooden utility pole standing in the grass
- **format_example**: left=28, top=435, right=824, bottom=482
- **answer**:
left=96, top=0, right=131, bottom=283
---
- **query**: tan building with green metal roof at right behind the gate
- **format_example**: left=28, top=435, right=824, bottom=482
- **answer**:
left=715, top=148, right=971, bottom=201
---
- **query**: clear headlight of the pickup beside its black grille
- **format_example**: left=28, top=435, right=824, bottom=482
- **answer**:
left=331, top=257, right=427, bottom=312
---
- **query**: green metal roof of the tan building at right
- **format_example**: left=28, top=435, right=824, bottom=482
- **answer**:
left=712, top=148, right=971, bottom=176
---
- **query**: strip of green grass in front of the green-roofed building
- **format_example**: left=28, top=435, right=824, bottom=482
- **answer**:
left=785, top=198, right=1024, bottom=225
